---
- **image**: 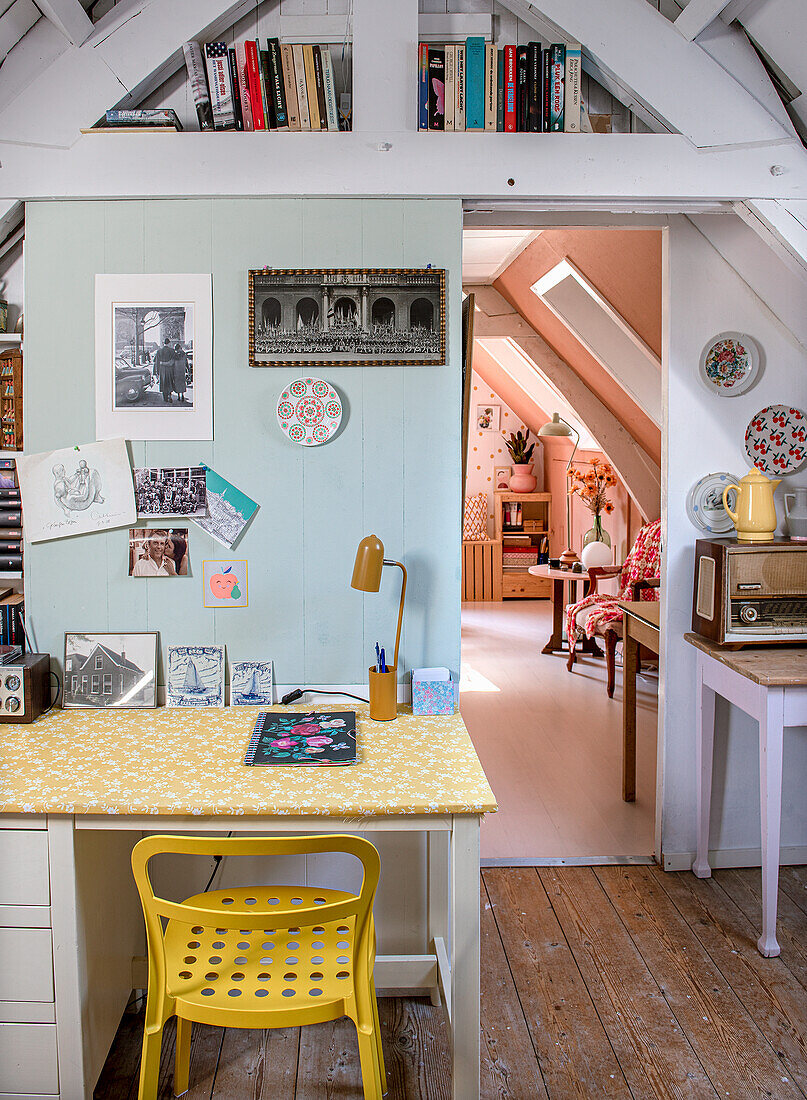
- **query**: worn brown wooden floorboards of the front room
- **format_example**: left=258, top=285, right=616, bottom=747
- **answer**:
left=93, top=867, right=807, bottom=1100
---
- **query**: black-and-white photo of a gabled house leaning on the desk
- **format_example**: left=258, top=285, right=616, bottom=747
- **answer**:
left=62, top=633, right=157, bottom=710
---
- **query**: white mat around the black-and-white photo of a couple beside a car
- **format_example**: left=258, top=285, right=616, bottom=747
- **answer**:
left=96, top=275, right=213, bottom=440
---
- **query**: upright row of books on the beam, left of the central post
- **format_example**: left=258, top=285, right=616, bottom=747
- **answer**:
left=183, top=39, right=350, bottom=130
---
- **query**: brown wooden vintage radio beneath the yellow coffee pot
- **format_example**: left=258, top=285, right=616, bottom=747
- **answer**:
left=693, top=538, right=807, bottom=646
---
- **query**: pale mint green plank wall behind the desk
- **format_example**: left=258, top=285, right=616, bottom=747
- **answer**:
left=25, top=198, right=462, bottom=684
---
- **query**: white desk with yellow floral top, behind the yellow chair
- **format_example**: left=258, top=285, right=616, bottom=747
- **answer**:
left=0, top=704, right=496, bottom=1100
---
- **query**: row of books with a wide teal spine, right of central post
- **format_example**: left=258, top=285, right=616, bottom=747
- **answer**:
left=418, top=36, right=584, bottom=133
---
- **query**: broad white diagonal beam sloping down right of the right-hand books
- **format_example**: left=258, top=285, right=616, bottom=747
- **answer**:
left=500, top=0, right=794, bottom=149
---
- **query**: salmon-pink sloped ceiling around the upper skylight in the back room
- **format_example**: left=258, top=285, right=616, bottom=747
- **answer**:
left=494, top=229, right=662, bottom=464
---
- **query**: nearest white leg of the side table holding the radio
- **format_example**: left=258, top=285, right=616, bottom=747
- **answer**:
left=756, top=688, right=785, bottom=958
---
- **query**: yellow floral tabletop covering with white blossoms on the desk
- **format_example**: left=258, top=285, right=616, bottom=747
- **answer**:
left=0, top=701, right=496, bottom=817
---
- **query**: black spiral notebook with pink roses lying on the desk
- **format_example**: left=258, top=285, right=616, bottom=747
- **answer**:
left=244, top=711, right=356, bottom=767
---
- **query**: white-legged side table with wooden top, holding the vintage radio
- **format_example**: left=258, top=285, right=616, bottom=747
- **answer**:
left=684, top=634, right=807, bottom=958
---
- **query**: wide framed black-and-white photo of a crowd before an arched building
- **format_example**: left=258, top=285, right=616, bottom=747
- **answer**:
left=250, top=267, right=445, bottom=366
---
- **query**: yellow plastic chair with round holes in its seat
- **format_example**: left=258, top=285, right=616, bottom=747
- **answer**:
left=132, top=835, right=387, bottom=1100
